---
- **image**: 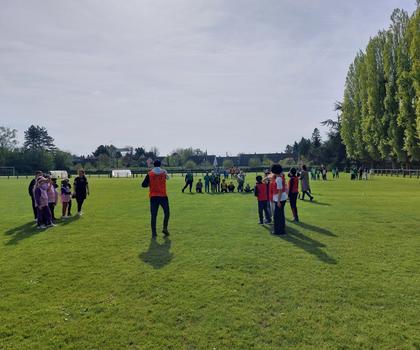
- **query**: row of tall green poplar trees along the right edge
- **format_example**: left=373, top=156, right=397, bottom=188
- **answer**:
left=339, top=4, right=420, bottom=165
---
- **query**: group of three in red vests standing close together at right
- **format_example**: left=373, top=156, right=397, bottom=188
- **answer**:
left=254, top=164, right=313, bottom=235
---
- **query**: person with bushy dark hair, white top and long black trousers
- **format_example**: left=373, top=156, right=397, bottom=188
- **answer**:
left=271, top=164, right=287, bottom=235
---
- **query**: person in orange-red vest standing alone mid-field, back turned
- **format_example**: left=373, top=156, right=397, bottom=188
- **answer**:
left=141, top=160, right=169, bottom=238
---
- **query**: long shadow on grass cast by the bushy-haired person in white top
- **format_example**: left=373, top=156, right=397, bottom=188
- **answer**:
left=264, top=226, right=337, bottom=265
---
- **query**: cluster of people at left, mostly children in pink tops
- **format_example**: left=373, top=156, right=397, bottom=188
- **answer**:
left=29, top=171, right=87, bottom=229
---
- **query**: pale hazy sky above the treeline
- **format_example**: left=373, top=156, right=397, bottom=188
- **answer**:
left=0, top=0, right=415, bottom=155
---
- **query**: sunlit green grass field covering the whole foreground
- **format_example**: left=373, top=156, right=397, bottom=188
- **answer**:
left=0, top=175, right=420, bottom=350
